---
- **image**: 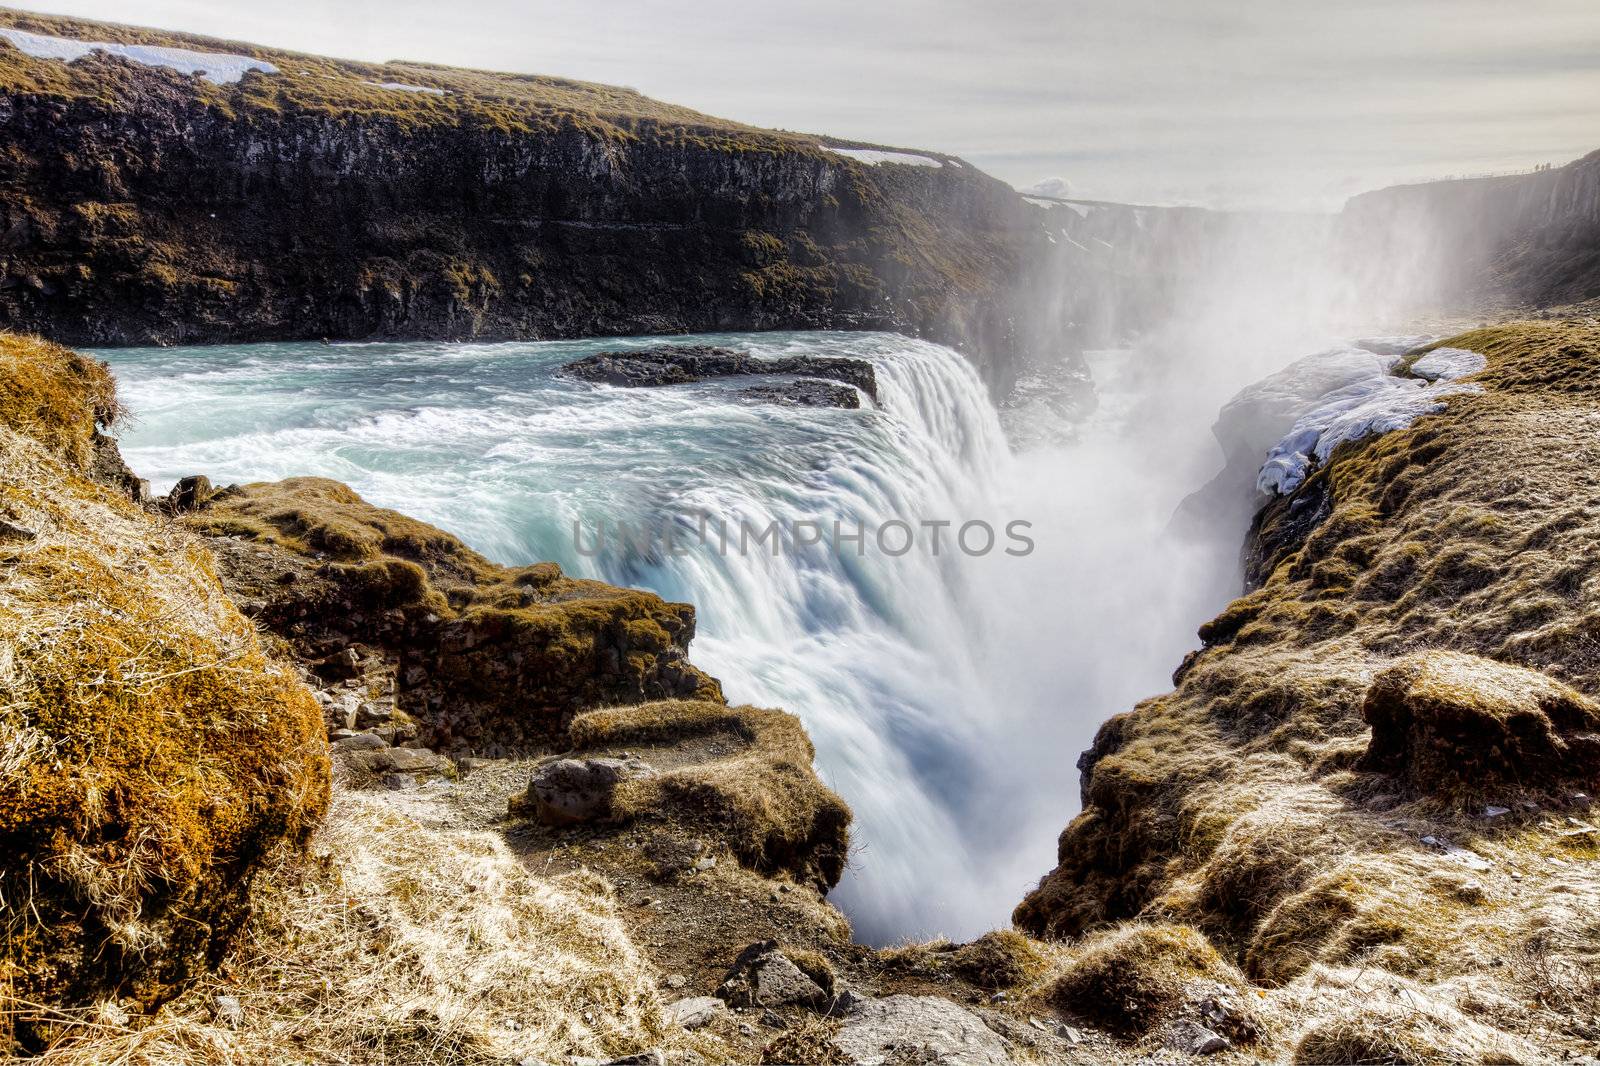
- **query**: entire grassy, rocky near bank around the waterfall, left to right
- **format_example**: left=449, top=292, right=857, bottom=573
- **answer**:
left=9, top=322, right=1600, bottom=1066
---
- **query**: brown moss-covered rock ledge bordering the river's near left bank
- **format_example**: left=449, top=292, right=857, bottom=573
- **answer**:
left=186, top=477, right=722, bottom=752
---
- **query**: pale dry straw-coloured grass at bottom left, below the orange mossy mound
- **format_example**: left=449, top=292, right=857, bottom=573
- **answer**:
left=25, top=789, right=686, bottom=1066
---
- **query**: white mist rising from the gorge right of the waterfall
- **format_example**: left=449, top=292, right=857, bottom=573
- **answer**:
left=889, top=191, right=1465, bottom=935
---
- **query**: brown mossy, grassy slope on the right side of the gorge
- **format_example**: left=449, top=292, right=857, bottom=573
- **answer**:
left=1016, top=320, right=1600, bottom=1061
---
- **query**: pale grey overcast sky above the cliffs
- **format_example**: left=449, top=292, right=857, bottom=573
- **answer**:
left=11, top=0, right=1600, bottom=206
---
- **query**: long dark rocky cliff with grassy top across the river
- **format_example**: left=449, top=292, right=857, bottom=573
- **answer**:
left=0, top=13, right=1056, bottom=387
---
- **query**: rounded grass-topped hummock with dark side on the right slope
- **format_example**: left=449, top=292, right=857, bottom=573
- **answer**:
left=1362, top=651, right=1600, bottom=791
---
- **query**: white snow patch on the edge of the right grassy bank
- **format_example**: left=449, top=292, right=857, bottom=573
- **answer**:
left=1256, top=349, right=1482, bottom=495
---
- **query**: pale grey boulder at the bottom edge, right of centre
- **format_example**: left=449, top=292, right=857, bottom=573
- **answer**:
left=832, top=996, right=1011, bottom=1066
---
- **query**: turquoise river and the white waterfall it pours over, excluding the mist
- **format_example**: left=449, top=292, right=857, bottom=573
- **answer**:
left=102, top=333, right=1024, bottom=940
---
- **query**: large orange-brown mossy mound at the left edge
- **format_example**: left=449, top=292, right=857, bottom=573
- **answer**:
left=0, top=336, right=328, bottom=1048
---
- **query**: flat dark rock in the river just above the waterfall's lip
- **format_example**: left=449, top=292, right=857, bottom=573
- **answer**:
left=562, top=344, right=878, bottom=407
